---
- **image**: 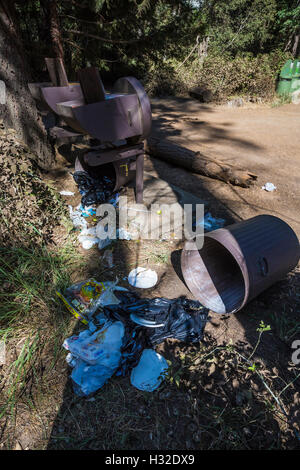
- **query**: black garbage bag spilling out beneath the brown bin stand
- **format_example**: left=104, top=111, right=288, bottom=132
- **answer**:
left=73, top=171, right=116, bottom=206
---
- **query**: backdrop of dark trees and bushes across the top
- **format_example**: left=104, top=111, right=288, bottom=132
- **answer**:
left=16, top=0, right=300, bottom=101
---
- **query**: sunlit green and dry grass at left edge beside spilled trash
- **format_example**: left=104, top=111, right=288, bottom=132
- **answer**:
left=0, top=243, right=81, bottom=418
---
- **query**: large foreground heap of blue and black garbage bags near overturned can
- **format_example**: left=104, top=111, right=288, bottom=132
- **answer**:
left=58, top=278, right=208, bottom=396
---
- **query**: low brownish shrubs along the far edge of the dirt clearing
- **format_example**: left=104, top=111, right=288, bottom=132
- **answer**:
left=146, top=51, right=291, bottom=102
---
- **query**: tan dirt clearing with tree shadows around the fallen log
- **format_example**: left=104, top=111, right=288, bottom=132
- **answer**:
left=146, top=98, right=300, bottom=236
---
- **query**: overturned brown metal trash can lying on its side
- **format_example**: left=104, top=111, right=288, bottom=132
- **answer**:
left=181, top=215, right=300, bottom=313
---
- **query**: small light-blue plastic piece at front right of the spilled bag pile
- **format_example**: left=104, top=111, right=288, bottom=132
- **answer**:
left=130, top=349, right=168, bottom=392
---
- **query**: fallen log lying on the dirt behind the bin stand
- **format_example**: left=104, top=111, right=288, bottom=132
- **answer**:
left=145, top=137, right=257, bottom=188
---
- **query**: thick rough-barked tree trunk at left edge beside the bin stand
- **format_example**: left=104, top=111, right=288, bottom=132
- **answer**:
left=0, top=0, right=54, bottom=168
